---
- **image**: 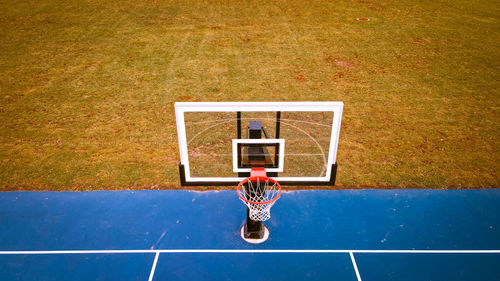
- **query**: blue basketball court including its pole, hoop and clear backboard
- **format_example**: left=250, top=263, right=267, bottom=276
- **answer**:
left=0, top=102, right=500, bottom=281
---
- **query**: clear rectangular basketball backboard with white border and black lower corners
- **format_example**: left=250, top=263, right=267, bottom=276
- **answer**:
left=175, top=102, right=343, bottom=186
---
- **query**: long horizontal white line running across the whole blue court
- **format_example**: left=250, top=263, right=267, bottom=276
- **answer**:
left=0, top=249, right=500, bottom=255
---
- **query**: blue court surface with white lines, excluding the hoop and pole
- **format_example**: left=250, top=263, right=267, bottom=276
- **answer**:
left=0, top=189, right=500, bottom=281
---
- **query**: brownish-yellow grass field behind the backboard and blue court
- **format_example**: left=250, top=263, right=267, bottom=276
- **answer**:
left=0, top=0, right=500, bottom=190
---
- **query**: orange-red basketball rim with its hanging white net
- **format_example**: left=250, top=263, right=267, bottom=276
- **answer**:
left=237, top=176, right=281, bottom=221
